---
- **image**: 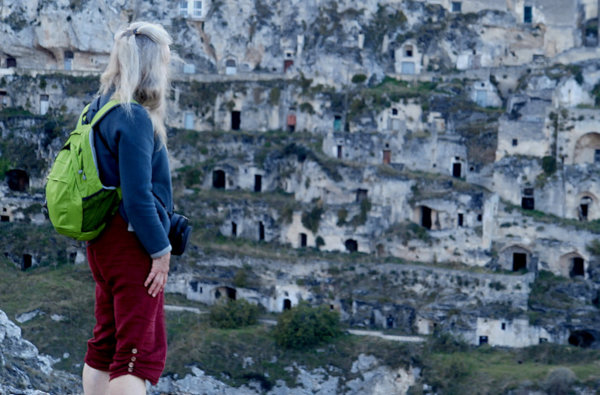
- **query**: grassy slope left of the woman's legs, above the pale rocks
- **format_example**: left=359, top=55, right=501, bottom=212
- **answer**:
left=0, top=258, right=95, bottom=374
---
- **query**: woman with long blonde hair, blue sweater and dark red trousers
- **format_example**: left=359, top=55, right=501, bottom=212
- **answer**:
left=83, top=22, right=173, bottom=395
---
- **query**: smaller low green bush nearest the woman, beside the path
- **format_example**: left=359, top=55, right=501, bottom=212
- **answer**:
left=208, top=299, right=259, bottom=329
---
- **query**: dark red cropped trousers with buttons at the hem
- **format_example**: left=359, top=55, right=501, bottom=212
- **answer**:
left=85, top=214, right=167, bottom=385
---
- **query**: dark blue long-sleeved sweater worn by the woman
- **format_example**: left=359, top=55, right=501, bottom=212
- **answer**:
left=87, top=95, right=173, bottom=258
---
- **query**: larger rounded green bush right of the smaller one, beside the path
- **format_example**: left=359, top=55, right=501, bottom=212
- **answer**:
left=274, top=301, right=342, bottom=349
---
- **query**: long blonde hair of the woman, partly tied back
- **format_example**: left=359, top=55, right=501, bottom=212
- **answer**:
left=100, top=22, right=172, bottom=144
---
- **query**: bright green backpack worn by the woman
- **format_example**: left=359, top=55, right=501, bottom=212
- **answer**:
left=46, top=100, right=121, bottom=240
